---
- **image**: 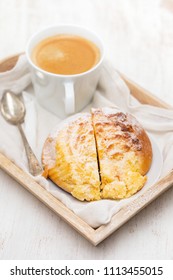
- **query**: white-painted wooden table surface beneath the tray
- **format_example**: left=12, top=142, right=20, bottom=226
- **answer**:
left=0, top=0, right=173, bottom=259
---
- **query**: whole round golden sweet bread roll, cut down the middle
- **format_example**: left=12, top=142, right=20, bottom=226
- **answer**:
left=42, top=108, right=152, bottom=201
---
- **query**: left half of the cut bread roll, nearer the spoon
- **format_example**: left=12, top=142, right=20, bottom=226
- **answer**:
left=42, top=113, right=100, bottom=201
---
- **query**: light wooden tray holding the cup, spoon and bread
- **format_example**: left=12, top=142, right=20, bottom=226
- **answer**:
left=0, top=55, right=173, bottom=246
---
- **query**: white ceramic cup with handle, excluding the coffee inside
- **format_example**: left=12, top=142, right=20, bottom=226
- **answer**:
left=26, top=25, right=104, bottom=118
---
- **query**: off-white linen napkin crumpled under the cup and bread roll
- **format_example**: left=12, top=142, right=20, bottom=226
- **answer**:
left=0, top=55, right=173, bottom=228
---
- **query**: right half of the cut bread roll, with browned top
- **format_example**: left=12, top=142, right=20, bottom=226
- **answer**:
left=91, top=108, right=152, bottom=199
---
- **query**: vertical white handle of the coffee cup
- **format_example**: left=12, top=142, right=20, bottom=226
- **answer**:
left=64, top=82, right=75, bottom=115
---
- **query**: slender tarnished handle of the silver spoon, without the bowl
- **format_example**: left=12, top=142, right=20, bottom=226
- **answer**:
left=17, top=124, right=43, bottom=176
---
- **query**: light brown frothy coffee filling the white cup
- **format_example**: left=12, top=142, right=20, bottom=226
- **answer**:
left=31, top=34, right=100, bottom=75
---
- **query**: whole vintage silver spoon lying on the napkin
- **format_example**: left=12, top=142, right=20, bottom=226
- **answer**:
left=0, top=91, right=43, bottom=176
